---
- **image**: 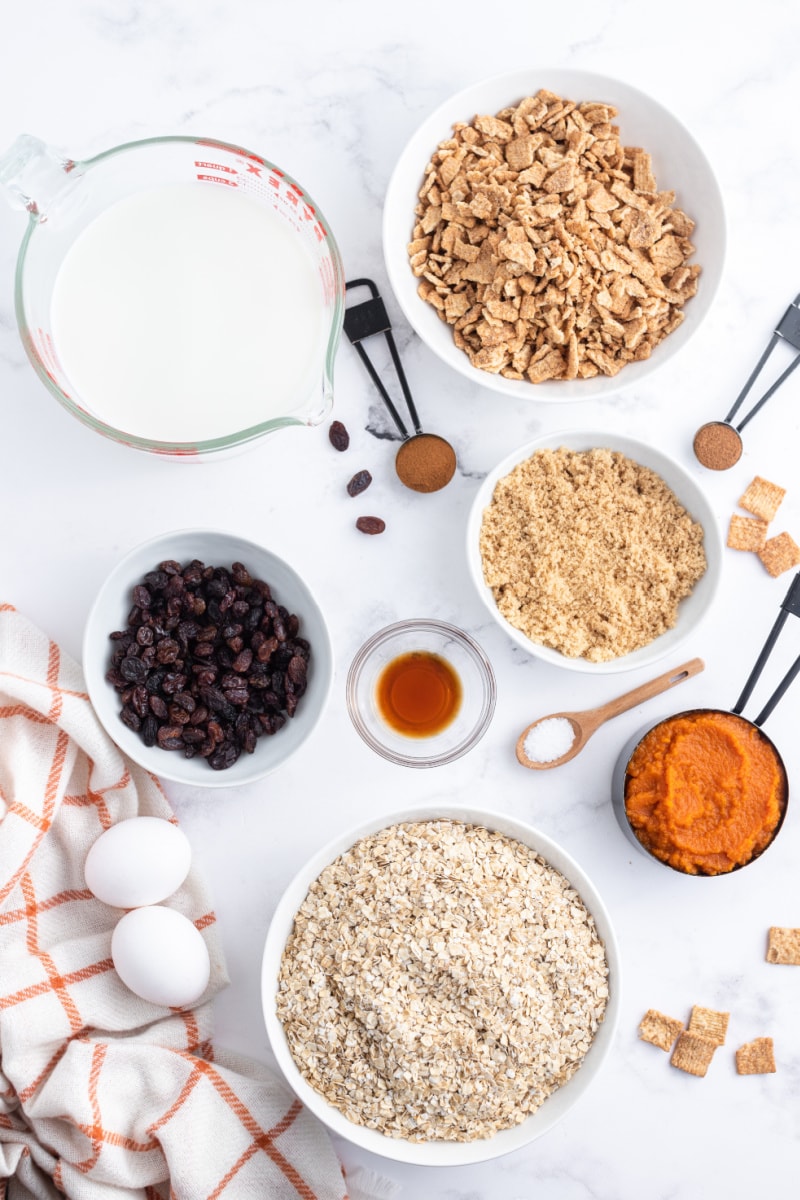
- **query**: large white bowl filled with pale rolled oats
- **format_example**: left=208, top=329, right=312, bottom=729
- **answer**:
left=261, top=804, right=620, bottom=1166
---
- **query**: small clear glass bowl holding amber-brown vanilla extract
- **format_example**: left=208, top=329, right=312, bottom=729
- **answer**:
left=347, top=619, right=497, bottom=767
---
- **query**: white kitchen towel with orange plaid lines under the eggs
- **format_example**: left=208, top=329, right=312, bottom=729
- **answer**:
left=0, top=605, right=356, bottom=1200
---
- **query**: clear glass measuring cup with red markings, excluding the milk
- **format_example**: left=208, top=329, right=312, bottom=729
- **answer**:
left=0, top=134, right=344, bottom=460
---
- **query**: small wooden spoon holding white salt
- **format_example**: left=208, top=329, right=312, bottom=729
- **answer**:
left=517, top=659, right=705, bottom=770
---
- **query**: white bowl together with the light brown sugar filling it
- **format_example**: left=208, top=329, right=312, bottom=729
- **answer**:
left=467, top=431, right=722, bottom=674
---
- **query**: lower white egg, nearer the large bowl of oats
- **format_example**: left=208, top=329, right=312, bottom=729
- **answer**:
left=112, top=905, right=211, bottom=1008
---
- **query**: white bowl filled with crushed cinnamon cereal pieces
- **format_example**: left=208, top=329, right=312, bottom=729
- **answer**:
left=383, top=67, right=726, bottom=401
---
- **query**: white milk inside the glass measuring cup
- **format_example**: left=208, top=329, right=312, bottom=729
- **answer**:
left=52, top=184, right=326, bottom=442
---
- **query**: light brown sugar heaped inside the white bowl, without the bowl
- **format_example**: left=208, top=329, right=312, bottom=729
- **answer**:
left=480, top=448, right=706, bottom=662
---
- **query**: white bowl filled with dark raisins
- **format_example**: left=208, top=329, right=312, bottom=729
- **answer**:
left=83, top=529, right=333, bottom=787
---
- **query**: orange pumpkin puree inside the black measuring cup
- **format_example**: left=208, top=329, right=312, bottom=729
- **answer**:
left=625, top=709, right=787, bottom=875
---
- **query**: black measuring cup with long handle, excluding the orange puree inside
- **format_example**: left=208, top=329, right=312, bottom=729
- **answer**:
left=612, top=572, right=800, bottom=877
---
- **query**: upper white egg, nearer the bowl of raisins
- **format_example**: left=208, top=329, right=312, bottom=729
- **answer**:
left=84, top=817, right=192, bottom=908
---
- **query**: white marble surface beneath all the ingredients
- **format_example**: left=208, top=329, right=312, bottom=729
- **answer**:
left=0, top=0, right=800, bottom=1200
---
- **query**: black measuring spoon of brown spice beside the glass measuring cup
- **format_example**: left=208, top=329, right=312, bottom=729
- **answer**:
left=344, top=280, right=456, bottom=492
